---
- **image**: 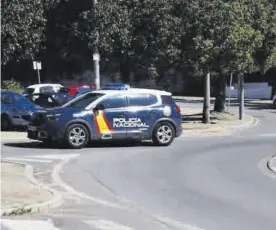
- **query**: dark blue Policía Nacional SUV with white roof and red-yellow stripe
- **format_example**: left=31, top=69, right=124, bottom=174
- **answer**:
left=28, top=89, right=182, bottom=148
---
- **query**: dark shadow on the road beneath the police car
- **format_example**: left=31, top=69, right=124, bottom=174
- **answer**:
left=4, top=141, right=155, bottom=151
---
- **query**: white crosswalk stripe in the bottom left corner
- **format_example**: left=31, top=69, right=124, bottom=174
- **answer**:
left=1, top=219, right=59, bottom=230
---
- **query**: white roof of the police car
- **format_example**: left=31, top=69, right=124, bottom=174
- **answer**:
left=92, top=88, right=172, bottom=96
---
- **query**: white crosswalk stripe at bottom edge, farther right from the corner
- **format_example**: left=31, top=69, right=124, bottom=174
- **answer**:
left=83, top=220, right=135, bottom=230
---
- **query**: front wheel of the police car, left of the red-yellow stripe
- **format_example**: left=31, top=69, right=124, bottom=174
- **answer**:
left=65, top=124, right=90, bottom=149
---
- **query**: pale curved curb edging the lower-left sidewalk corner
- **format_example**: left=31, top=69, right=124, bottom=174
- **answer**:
left=1, top=160, right=63, bottom=216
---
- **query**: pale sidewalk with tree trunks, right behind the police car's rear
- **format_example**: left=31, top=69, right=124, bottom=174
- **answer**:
left=181, top=107, right=257, bottom=136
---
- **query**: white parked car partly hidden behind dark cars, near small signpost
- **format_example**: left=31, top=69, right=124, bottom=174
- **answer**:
left=23, top=84, right=64, bottom=96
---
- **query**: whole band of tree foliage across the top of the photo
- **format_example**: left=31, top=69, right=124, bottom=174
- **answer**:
left=1, top=0, right=276, bottom=85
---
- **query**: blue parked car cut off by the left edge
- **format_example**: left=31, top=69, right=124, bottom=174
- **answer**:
left=1, top=90, right=41, bottom=130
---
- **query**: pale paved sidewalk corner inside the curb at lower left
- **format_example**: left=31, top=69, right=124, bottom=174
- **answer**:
left=1, top=162, right=53, bottom=215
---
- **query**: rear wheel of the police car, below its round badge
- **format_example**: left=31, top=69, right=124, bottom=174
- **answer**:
left=152, top=121, right=175, bottom=146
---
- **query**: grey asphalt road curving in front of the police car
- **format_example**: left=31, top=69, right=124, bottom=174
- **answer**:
left=2, top=104, right=276, bottom=230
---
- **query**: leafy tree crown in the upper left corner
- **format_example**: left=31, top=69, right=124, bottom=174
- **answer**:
left=1, top=0, right=46, bottom=65
